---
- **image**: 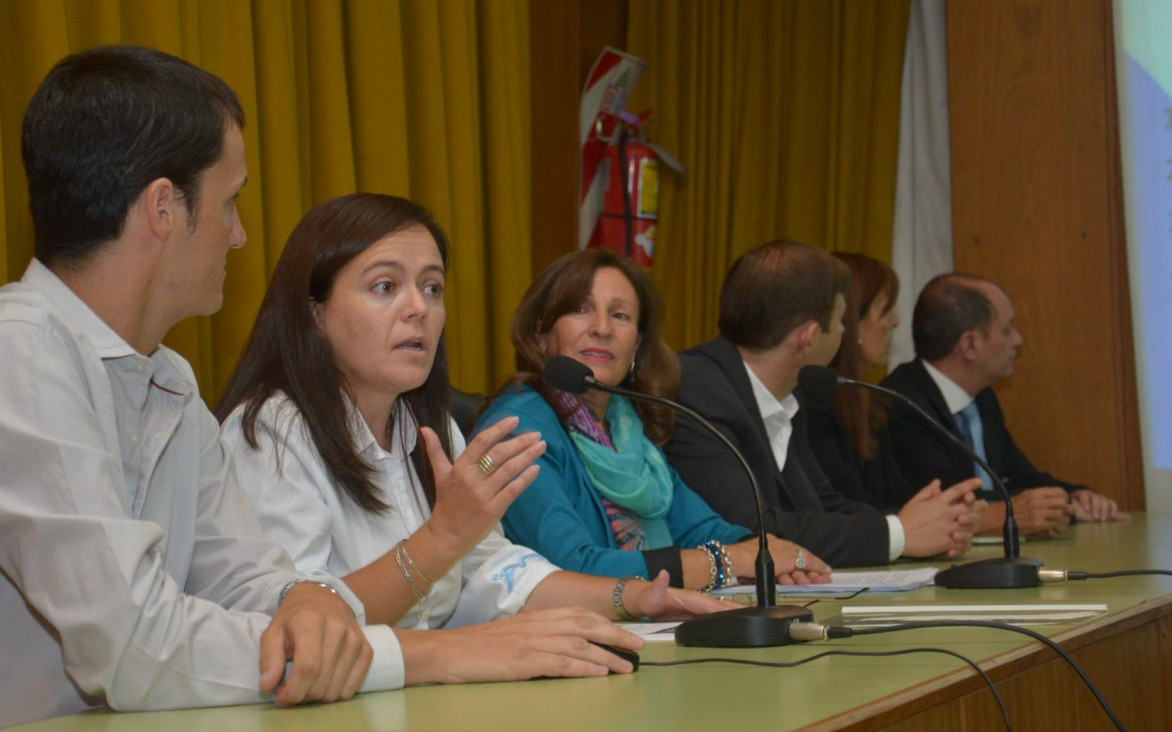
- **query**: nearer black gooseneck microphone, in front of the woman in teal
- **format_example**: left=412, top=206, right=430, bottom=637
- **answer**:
left=543, top=356, right=813, bottom=648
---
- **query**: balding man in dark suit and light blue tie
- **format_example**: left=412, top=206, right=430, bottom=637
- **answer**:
left=884, top=273, right=1120, bottom=535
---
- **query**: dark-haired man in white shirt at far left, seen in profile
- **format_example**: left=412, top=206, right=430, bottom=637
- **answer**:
left=0, top=47, right=393, bottom=726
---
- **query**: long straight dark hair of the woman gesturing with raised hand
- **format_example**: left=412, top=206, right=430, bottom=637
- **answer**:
left=216, top=193, right=452, bottom=513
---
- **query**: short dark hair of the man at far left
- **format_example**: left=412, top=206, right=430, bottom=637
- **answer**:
left=21, top=46, right=244, bottom=266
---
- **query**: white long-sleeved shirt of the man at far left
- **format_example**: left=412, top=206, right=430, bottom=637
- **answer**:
left=0, top=259, right=403, bottom=726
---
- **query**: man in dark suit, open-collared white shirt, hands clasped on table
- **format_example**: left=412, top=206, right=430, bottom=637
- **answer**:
left=665, top=241, right=976, bottom=566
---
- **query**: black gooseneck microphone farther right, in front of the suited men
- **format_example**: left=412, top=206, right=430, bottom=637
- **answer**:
left=798, top=365, right=1042, bottom=589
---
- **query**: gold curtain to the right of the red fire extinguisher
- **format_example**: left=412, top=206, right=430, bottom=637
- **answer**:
left=627, top=0, right=908, bottom=348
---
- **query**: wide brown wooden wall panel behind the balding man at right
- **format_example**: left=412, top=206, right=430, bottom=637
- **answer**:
left=947, top=0, right=1144, bottom=509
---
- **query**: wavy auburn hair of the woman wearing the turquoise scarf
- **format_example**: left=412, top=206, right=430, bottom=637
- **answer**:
left=505, top=249, right=680, bottom=445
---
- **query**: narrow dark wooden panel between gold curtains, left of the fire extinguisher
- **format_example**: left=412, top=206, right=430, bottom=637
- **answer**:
left=530, top=0, right=627, bottom=276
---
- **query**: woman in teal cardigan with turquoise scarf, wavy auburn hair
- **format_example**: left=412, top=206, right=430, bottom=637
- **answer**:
left=477, top=249, right=830, bottom=589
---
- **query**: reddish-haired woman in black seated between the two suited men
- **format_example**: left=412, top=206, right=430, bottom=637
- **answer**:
left=805, top=253, right=983, bottom=510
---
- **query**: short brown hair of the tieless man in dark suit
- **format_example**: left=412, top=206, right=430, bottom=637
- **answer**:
left=720, top=239, right=851, bottom=351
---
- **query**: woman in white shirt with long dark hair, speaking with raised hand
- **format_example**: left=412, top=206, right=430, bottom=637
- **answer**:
left=218, top=193, right=723, bottom=684
